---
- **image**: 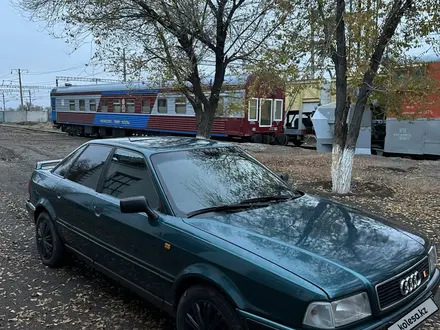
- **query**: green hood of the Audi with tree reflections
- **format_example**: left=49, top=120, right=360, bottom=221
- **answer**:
left=184, top=195, right=427, bottom=298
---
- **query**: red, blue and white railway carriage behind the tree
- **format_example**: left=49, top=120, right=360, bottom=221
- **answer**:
left=51, top=77, right=285, bottom=143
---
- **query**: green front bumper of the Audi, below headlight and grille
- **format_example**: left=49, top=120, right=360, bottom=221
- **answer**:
left=239, top=269, right=440, bottom=330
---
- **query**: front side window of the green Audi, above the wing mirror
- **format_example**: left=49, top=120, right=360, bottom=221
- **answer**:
left=102, top=149, right=159, bottom=209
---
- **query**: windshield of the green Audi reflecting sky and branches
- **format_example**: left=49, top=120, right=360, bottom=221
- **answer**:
left=151, top=147, right=296, bottom=216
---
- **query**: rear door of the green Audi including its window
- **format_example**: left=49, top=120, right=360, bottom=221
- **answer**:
left=55, top=144, right=112, bottom=258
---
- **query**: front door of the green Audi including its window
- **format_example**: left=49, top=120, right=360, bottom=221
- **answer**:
left=89, top=148, right=163, bottom=299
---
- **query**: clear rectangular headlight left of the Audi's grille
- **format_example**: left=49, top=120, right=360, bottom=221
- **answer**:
left=303, top=292, right=371, bottom=329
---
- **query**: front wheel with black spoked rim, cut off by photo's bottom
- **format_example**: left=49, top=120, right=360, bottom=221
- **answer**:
left=176, top=285, right=243, bottom=330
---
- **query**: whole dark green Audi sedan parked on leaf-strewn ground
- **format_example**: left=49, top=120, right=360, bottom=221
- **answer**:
left=26, top=137, right=440, bottom=330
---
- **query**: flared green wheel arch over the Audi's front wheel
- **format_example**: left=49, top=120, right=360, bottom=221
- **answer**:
left=173, top=263, right=246, bottom=309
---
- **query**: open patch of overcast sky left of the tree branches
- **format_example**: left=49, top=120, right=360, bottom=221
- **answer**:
left=0, top=0, right=115, bottom=108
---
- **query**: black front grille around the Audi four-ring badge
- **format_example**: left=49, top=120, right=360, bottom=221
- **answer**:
left=376, top=257, right=429, bottom=310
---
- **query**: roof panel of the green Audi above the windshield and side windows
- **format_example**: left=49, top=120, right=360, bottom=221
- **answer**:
left=88, top=136, right=233, bottom=154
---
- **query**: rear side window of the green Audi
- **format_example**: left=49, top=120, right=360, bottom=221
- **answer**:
left=66, top=144, right=112, bottom=189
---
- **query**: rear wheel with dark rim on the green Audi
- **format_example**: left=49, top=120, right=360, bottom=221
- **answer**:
left=35, top=212, right=67, bottom=268
